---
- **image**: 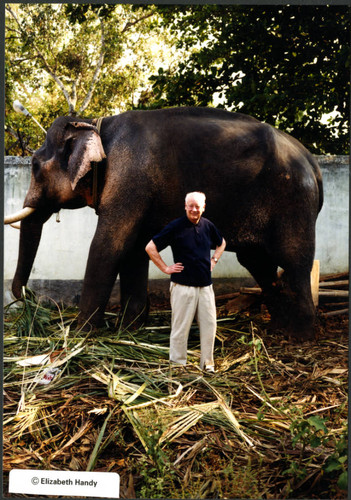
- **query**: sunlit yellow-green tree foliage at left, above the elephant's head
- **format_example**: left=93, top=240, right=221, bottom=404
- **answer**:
left=5, top=3, right=162, bottom=154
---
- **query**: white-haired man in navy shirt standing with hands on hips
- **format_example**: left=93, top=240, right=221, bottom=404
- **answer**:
left=145, top=192, right=226, bottom=372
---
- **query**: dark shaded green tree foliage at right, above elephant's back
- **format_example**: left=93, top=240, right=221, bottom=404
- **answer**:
left=149, top=5, right=350, bottom=154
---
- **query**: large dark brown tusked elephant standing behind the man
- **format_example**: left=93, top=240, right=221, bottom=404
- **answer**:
left=5, top=107, right=323, bottom=340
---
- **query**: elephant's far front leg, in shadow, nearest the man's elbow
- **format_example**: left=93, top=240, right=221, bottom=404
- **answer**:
left=119, top=244, right=149, bottom=328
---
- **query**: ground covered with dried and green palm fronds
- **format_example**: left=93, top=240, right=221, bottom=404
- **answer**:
left=3, top=290, right=348, bottom=498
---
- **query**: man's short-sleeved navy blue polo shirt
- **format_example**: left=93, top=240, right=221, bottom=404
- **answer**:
left=152, top=215, right=223, bottom=286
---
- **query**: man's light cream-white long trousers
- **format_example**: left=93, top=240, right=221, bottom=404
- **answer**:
left=169, top=282, right=217, bottom=369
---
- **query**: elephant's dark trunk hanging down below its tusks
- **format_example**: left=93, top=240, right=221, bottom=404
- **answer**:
left=12, top=213, right=51, bottom=298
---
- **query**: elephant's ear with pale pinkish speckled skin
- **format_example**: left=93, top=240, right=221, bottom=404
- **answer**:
left=66, top=122, right=106, bottom=190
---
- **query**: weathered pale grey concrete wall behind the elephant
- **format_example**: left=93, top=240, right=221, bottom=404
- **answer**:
left=4, top=156, right=349, bottom=303
